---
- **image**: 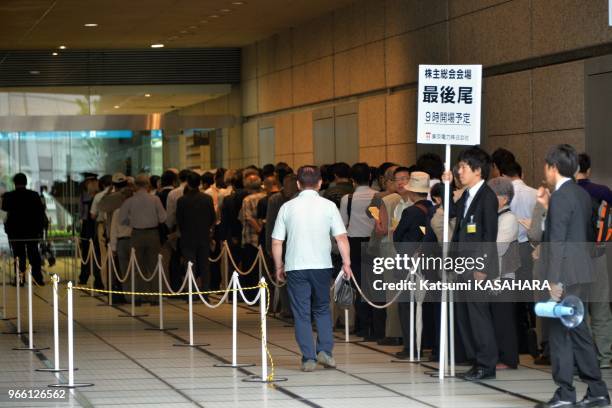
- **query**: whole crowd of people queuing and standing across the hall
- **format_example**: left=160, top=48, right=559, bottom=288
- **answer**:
left=2, top=145, right=612, bottom=406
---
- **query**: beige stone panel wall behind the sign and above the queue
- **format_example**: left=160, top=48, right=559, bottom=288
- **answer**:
left=185, top=0, right=612, bottom=183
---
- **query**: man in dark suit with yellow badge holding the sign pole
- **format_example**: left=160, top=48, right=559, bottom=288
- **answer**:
left=444, top=147, right=498, bottom=381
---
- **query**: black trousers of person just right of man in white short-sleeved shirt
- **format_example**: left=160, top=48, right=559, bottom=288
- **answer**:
left=349, top=237, right=378, bottom=337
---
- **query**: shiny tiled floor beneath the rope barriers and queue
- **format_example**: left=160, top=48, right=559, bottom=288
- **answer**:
left=0, top=280, right=612, bottom=408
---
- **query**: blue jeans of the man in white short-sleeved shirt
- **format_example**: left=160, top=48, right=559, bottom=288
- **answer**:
left=287, top=268, right=334, bottom=361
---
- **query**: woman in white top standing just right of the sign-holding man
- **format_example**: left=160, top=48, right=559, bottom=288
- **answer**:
left=488, top=177, right=521, bottom=370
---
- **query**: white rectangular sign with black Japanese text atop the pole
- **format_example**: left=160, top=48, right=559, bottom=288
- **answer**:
left=417, top=65, right=482, bottom=145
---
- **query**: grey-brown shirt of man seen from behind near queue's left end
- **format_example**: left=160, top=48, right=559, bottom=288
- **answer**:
left=119, top=189, right=166, bottom=229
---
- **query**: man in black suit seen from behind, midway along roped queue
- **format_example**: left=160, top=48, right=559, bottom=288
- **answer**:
left=176, top=172, right=217, bottom=290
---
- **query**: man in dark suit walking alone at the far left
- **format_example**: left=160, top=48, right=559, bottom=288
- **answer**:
left=2, top=173, right=47, bottom=285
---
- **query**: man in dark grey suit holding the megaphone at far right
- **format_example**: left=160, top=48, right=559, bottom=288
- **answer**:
left=537, top=144, right=610, bottom=408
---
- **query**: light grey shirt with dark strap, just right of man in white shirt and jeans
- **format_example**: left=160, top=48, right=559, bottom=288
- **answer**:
left=340, top=186, right=376, bottom=238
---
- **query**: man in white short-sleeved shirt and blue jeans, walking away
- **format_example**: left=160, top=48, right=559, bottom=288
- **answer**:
left=272, top=166, right=352, bottom=371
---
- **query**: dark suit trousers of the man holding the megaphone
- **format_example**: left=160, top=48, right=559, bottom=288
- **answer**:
left=548, top=285, right=608, bottom=402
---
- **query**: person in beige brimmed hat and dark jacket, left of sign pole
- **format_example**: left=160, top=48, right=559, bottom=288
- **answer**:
left=393, top=171, right=433, bottom=359
